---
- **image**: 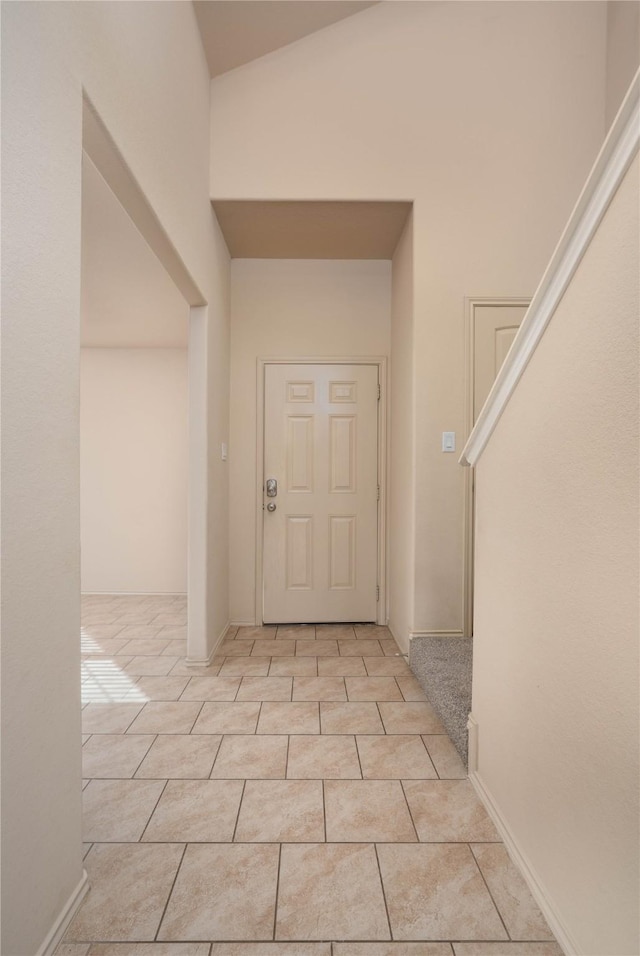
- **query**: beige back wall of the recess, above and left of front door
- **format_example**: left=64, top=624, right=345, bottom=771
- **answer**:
left=229, top=259, right=391, bottom=623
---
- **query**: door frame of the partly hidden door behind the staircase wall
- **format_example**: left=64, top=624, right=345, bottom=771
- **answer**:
left=462, top=295, right=531, bottom=637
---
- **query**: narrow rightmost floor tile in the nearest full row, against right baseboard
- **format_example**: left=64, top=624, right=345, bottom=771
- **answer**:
left=471, top=843, right=553, bottom=941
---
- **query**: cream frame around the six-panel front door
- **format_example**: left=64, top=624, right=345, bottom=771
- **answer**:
left=255, top=355, right=388, bottom=625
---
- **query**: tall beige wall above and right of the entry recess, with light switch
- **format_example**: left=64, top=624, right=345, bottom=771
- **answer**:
left=211, top=2, right=606, bottom=642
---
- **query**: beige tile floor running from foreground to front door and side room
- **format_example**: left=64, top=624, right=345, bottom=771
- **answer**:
left=57, top=596, right=562, bottom=956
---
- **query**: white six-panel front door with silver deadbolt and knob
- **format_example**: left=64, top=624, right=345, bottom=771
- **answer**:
left=263, top=364, right=378, bottom=624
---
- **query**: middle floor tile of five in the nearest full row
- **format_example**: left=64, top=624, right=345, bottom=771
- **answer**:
left=276, top=843, right=390, bottom=940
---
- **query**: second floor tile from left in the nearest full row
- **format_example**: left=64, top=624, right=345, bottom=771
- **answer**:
left=157, top=843, right=280, bottom=940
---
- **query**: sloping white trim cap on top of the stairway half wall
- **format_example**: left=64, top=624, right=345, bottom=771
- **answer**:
left=460, top=70, right=640, bottom=465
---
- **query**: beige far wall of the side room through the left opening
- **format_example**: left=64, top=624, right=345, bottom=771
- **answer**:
left=80, top=348, right=188, bottom=593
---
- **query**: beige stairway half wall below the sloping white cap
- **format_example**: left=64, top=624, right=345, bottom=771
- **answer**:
left=473, top=160, right=640, bottom=956
